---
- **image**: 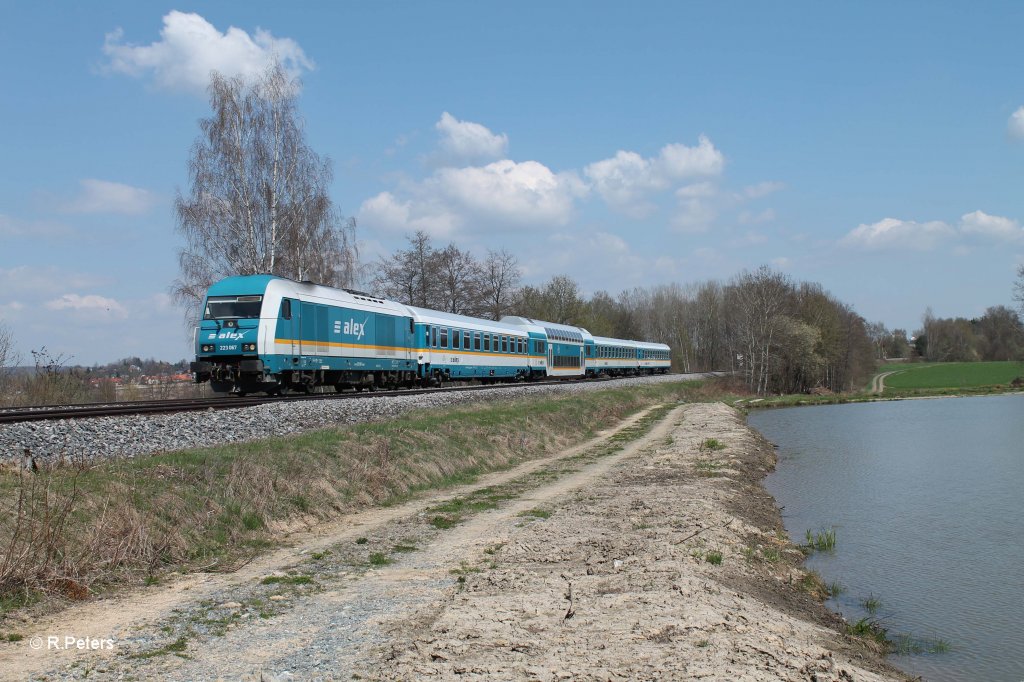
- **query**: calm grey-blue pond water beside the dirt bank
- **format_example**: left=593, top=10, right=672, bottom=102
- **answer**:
left=749, top=395, right=1024, bottom=682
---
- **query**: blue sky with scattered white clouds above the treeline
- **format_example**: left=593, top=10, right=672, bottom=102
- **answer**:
left=0, top=2, right=1024, bottom=363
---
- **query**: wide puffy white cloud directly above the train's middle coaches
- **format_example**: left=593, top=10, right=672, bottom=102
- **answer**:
left=359, top=159, right=587, bottom=237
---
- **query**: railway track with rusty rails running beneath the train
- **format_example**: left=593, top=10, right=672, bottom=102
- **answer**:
left=0, top=379, right=613, bottom=424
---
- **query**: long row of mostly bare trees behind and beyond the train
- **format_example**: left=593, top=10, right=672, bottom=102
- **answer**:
left=370, top=232, right=1024, bottom=394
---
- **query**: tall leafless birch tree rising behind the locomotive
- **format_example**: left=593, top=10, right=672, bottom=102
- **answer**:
left=172, top=58, right=357, bottom=321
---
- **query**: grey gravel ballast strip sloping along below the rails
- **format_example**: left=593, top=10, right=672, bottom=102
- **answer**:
left=0, top=374, right=702, bottom=463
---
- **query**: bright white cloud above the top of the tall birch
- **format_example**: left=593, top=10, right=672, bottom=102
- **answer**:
left=103, top=10, right=313, bottom=92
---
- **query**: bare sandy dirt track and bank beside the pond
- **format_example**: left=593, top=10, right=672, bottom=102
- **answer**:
left=0, top=403, right=903, bottom=681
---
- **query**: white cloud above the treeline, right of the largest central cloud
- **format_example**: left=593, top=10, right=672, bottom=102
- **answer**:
left=584, top=135, right=725, bottom=217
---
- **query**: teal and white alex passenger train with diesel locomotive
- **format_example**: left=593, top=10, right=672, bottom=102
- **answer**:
left=190, top=274, right=671, bottom=395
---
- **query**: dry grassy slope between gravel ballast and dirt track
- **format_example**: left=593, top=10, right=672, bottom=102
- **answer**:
left=0, top=382, right=701, bottom=615
